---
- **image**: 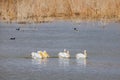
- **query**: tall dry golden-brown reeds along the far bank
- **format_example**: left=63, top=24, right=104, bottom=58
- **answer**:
left=0, top=0, right=120, bottom=22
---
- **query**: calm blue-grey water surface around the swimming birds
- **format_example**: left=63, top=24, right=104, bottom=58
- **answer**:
left=0, top=21, right=120, bottom=80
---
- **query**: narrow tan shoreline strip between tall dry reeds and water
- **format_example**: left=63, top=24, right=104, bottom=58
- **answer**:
left=0, top=17, right=120, bottom=24
